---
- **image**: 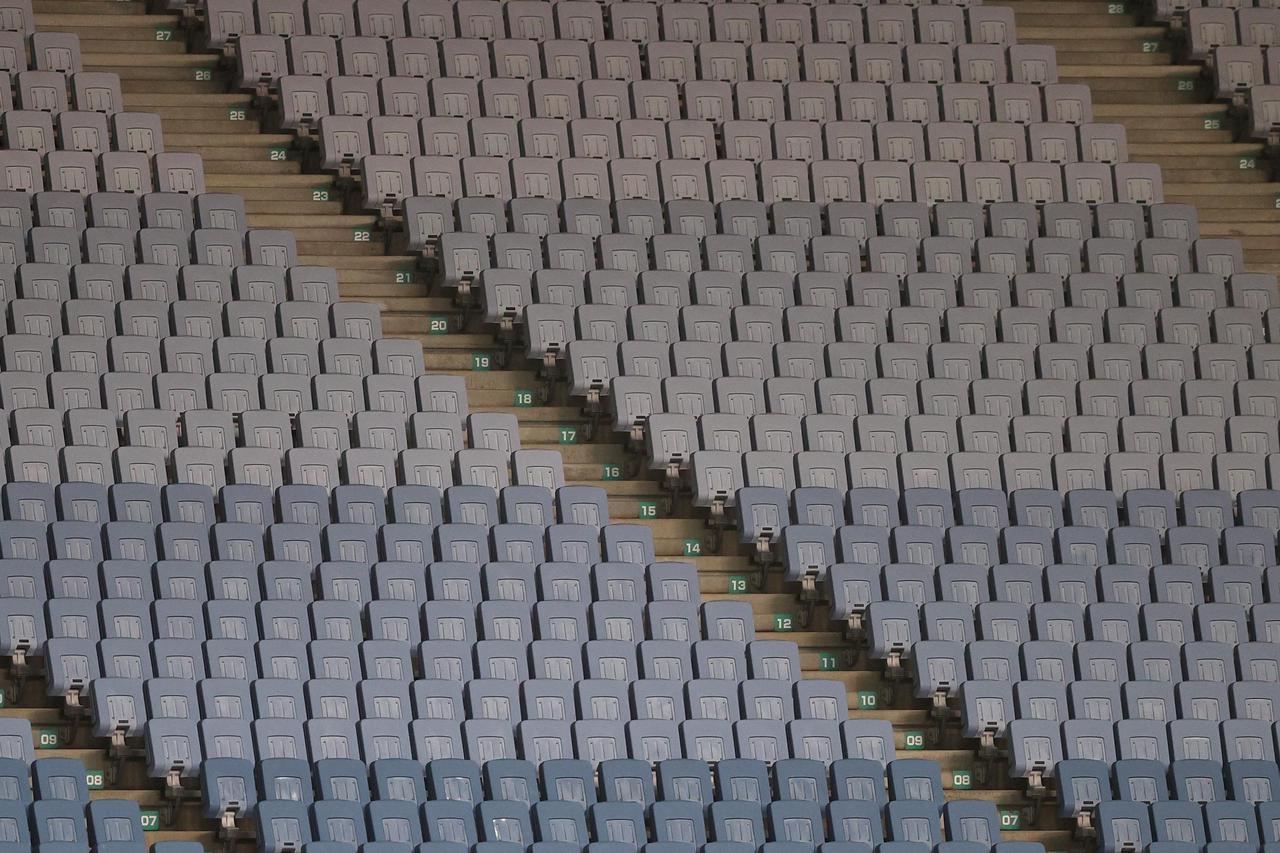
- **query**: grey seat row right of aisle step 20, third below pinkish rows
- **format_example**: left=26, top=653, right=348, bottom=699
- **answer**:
left=499, top=284, right=1275, bottom=343
